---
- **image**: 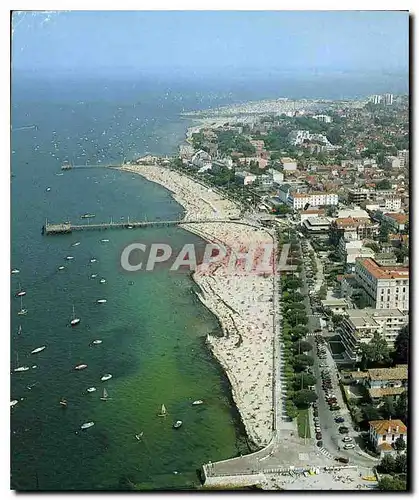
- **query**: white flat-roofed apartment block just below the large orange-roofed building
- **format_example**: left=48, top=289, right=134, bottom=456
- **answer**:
left=336, top=308, right=409, bottom=362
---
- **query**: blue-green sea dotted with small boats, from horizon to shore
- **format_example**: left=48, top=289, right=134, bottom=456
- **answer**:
left=10, top=72, right=410, bottom=491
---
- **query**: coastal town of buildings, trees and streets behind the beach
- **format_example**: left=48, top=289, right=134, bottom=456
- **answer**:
left=138, top=94, right=409, bottom=490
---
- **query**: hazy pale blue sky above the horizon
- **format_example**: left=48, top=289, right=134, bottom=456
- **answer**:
left=12, top=11, right=409, bottom=75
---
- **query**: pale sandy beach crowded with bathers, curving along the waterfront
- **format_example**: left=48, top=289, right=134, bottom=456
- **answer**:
left=121, top=165, right=273, bottom=446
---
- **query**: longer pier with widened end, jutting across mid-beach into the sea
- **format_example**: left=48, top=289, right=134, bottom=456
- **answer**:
left=42, top=218, right=244, bottom=235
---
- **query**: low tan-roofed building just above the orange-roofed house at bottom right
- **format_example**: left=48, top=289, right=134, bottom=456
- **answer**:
left=351, top=365, right=409, bottom=403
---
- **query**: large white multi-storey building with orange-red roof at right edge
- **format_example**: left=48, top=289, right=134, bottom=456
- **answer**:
left=355, top=259, right=409, bottom=311
